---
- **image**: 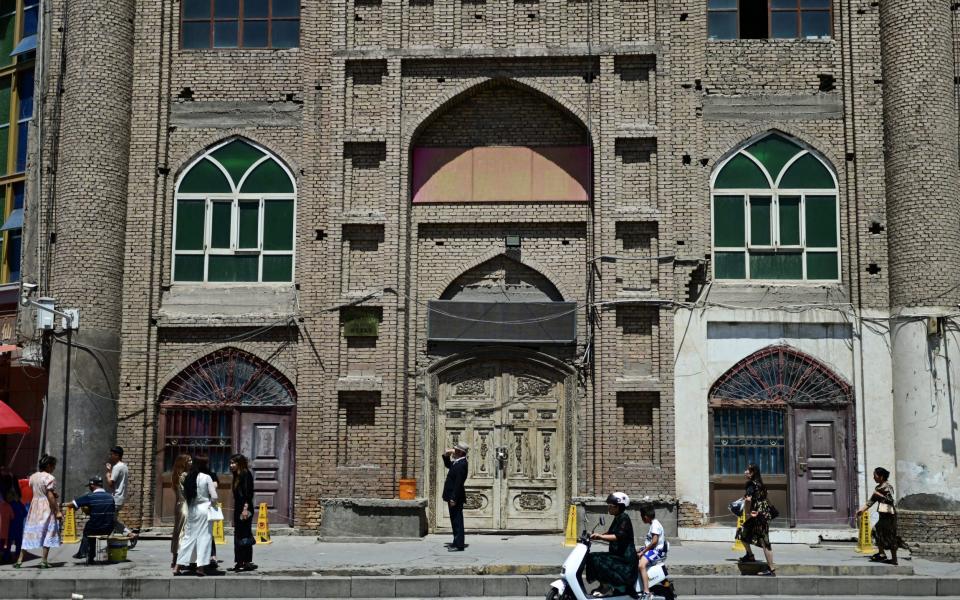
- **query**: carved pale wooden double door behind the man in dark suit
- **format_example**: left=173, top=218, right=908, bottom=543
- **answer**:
left=436, top=361, right=566, bottom=531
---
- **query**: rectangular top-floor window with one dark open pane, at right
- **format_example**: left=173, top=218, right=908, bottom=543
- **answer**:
left=707, top=0, right=833, bottom=40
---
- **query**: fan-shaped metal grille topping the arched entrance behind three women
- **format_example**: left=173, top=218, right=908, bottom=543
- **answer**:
left=162, top=348, right=296, bottom=408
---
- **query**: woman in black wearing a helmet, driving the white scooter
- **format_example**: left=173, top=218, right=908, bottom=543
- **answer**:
left=587, top=492, right=638, bottom=597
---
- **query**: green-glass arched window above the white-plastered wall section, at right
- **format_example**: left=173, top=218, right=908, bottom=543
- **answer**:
left=711, top=133, right=840, bottom=281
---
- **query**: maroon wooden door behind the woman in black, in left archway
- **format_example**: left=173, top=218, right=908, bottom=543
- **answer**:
left=240, top=412, right=293, bottom=527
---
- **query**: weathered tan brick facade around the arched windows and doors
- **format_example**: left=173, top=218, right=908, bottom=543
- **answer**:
left=18, top=0, right=960, bottom=548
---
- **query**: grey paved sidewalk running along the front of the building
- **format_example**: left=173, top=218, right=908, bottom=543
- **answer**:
left=0, top=535, right=960, bottom=578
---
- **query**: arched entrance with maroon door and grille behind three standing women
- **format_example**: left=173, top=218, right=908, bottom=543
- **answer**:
left=154, top=348, right=296, bottom=526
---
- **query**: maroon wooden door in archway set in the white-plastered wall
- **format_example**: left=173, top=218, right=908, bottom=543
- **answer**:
left=793, top=409, right=850, bottom=527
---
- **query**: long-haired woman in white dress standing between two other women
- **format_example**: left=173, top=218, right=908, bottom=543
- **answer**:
left=173, top=456, right=217, bottom=577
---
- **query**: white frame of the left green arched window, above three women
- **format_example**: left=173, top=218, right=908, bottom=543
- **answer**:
left=170, top=138, right=297, bottom=285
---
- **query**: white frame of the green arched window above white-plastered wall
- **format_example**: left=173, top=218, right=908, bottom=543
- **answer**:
left=710, top=141, right=843, bottom=285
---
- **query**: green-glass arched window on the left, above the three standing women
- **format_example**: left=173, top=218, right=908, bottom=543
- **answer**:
left=173, top=138, right=296, bottom=283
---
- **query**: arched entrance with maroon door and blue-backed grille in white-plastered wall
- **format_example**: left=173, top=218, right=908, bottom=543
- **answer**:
left=709, top=346, right=855, bottom=527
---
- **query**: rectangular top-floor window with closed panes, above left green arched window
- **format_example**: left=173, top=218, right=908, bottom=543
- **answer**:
left=180, top=0, right=300, bottom=48
